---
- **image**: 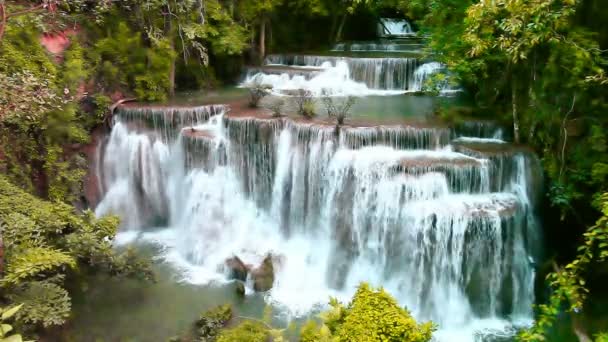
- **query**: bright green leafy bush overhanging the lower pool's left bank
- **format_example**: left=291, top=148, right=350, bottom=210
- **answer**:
left=0, top=176, right=152, bottom=327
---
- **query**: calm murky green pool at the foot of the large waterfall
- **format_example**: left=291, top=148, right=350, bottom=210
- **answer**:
left=60, top=243, right=274, bottom=342
